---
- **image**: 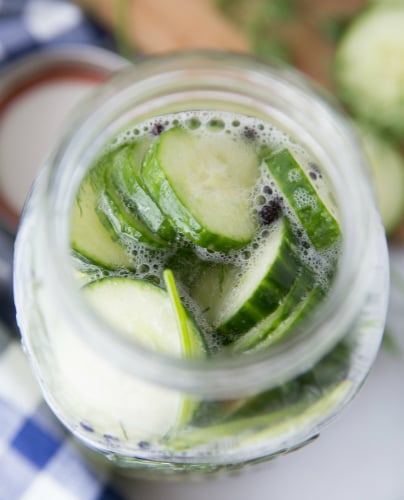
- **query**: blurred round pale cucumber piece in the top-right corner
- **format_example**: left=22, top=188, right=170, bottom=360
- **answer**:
left=335, top=1, right=404, bottom=138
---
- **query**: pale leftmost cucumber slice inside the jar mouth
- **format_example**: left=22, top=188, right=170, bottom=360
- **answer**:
left=70, top=173, right=133, bottom=269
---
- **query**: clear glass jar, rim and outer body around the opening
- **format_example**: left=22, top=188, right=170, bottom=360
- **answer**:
left=15, top=52, right=388, bottom=473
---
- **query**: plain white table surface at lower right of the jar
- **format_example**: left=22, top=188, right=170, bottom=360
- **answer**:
left=119, top=250, right=404, bottom=500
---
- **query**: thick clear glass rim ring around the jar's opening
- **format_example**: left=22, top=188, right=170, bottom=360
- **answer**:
left=41, top=51, right=375, bottom=398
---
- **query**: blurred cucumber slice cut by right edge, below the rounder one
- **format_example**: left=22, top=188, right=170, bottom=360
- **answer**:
left=359, top=126, right=404, bottom=234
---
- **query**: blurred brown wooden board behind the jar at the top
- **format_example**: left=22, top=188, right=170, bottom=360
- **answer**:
left=76, top=0, right=365, bottom=86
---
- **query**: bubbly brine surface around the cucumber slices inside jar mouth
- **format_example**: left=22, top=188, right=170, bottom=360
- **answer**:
left=76, top=111, right=338, bottom=352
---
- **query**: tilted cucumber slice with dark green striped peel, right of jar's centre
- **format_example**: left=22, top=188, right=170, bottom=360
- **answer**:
left=192, top=218, right=300, bottom=341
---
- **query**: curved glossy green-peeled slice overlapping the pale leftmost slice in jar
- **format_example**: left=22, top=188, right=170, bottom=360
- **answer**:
left=105, top=142, right=176, bottom=245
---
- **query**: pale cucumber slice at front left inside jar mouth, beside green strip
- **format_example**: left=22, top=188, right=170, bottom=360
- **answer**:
left=82, top=276, right=206, bottom=357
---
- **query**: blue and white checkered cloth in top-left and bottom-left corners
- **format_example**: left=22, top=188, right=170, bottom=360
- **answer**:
left=0, top=0, right=122, bottom=500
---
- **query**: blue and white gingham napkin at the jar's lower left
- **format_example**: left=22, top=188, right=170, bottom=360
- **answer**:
left=0, top=323, right=121, bottom=500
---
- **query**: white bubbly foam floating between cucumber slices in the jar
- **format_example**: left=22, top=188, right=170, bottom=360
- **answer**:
left=77, top=110, right=339, bottom=352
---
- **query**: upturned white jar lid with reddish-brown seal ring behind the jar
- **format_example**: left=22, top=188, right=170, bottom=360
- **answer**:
left=0, top=45, right=128, bottom=232
